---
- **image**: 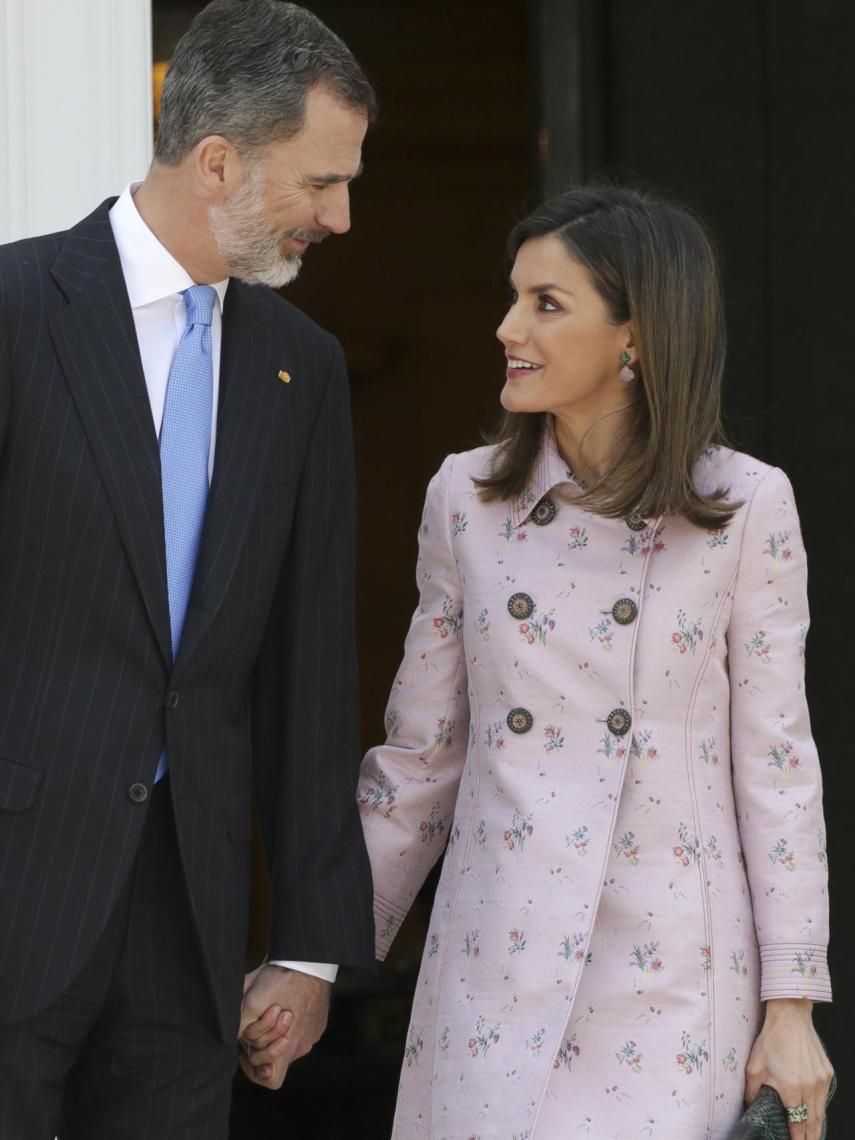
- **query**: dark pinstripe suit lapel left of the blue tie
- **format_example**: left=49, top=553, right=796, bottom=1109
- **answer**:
left=50, top=201, right=172, bottom=666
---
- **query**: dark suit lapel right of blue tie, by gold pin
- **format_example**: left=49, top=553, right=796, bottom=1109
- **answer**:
left=178, top=280, right=287, bottom=666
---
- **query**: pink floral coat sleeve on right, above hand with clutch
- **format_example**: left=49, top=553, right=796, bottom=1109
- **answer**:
left=727, top=469, right=831, bottom=1001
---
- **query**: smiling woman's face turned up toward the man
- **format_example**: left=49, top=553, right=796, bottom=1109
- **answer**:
left=496, top=236, right=637, bottom=422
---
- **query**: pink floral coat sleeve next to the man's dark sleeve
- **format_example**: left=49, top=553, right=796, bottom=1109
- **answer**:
left=358, top=456, right=469, bottom=960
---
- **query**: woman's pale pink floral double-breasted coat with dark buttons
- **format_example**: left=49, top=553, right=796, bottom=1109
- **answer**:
left=359, top=437, right=830, bottom=1140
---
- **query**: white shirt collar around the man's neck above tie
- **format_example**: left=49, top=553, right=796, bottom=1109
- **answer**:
left=109, top=182, right=229, bottom=310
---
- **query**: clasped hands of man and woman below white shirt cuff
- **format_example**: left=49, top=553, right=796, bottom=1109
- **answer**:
left=239, top=966, right=333, bottom=1089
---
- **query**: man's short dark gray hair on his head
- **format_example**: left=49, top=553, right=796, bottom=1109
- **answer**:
left=154, top=0, right=377, bottom=166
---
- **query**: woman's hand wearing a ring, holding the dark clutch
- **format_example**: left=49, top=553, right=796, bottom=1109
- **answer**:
left=746, top=998, right=833, bottom=1140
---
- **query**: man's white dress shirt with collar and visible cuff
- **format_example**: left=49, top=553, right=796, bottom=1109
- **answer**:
left=109, top=182, right=339, bottom=982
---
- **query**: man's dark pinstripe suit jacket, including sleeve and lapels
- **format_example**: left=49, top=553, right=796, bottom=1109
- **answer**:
left=0, top=202, right=374, bottom=1040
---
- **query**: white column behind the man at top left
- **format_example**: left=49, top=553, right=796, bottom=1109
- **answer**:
left=0, top=0, right=152, bottom=243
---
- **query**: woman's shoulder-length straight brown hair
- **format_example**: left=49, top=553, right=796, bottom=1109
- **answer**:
left=477, top=185, right=739, bottom=528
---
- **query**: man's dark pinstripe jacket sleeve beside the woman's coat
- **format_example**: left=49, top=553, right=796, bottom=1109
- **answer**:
left=253, top=337, right=374, bottom=968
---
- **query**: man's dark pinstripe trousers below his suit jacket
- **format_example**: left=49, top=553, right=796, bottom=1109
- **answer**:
left=0, top=782, right=237, bottom=1140
